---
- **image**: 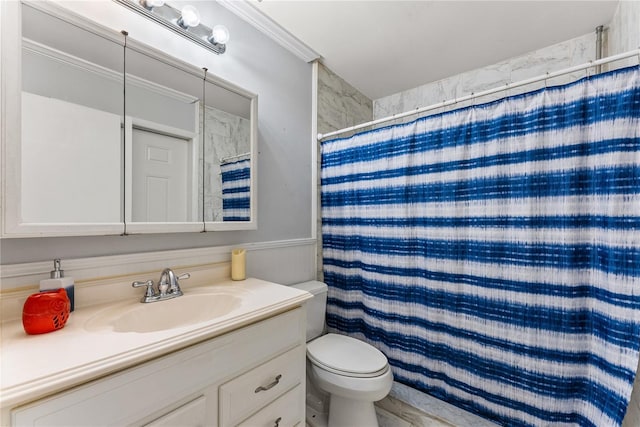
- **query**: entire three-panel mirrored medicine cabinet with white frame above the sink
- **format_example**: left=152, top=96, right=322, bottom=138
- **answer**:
left=0, top=1, right=257, bottom=237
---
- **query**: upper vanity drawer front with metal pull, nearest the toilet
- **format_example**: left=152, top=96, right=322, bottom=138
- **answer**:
left=219, top=345, right=305, bottom=427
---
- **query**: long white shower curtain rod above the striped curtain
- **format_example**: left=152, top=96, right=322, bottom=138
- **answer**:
left=318, top=48, right=640, bottom=141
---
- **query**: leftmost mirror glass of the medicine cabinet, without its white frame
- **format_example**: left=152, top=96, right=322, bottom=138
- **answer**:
left=20, top=4, right=123, bottom=224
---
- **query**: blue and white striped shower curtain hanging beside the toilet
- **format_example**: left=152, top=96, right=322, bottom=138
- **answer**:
left=322, top=67, right=640, bottom=427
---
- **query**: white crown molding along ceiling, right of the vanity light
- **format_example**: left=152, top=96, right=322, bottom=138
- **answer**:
left=218, top=0, right=320, bottom=62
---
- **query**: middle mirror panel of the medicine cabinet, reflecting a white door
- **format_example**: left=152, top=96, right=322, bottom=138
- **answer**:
left=125, top=42, right=204, bottom=233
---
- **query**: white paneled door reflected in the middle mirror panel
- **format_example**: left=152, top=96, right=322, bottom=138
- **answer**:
left=131, top=128, right=191, bottom=222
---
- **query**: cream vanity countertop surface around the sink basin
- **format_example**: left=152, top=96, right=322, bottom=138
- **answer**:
left=0, top=278, right=311, bottom=408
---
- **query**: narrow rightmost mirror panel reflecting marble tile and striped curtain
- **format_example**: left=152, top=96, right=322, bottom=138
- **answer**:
left=204, top=81, right=251, bottom=222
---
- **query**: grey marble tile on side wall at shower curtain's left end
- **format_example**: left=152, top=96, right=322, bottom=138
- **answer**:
left=316, top=63, right=373, bottom=280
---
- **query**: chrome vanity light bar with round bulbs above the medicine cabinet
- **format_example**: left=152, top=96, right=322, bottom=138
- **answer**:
left=114, top=0, right=229, bottom=55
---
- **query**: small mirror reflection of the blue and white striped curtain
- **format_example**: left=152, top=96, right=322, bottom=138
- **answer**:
left=220, top=159, right=251, bottom=221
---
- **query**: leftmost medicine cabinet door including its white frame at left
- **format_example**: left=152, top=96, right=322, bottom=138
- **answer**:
left=2, top=2, right=124, bottom=237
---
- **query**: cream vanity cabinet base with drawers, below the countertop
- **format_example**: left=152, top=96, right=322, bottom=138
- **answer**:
left=11, top=308, right=306, bottom=427
